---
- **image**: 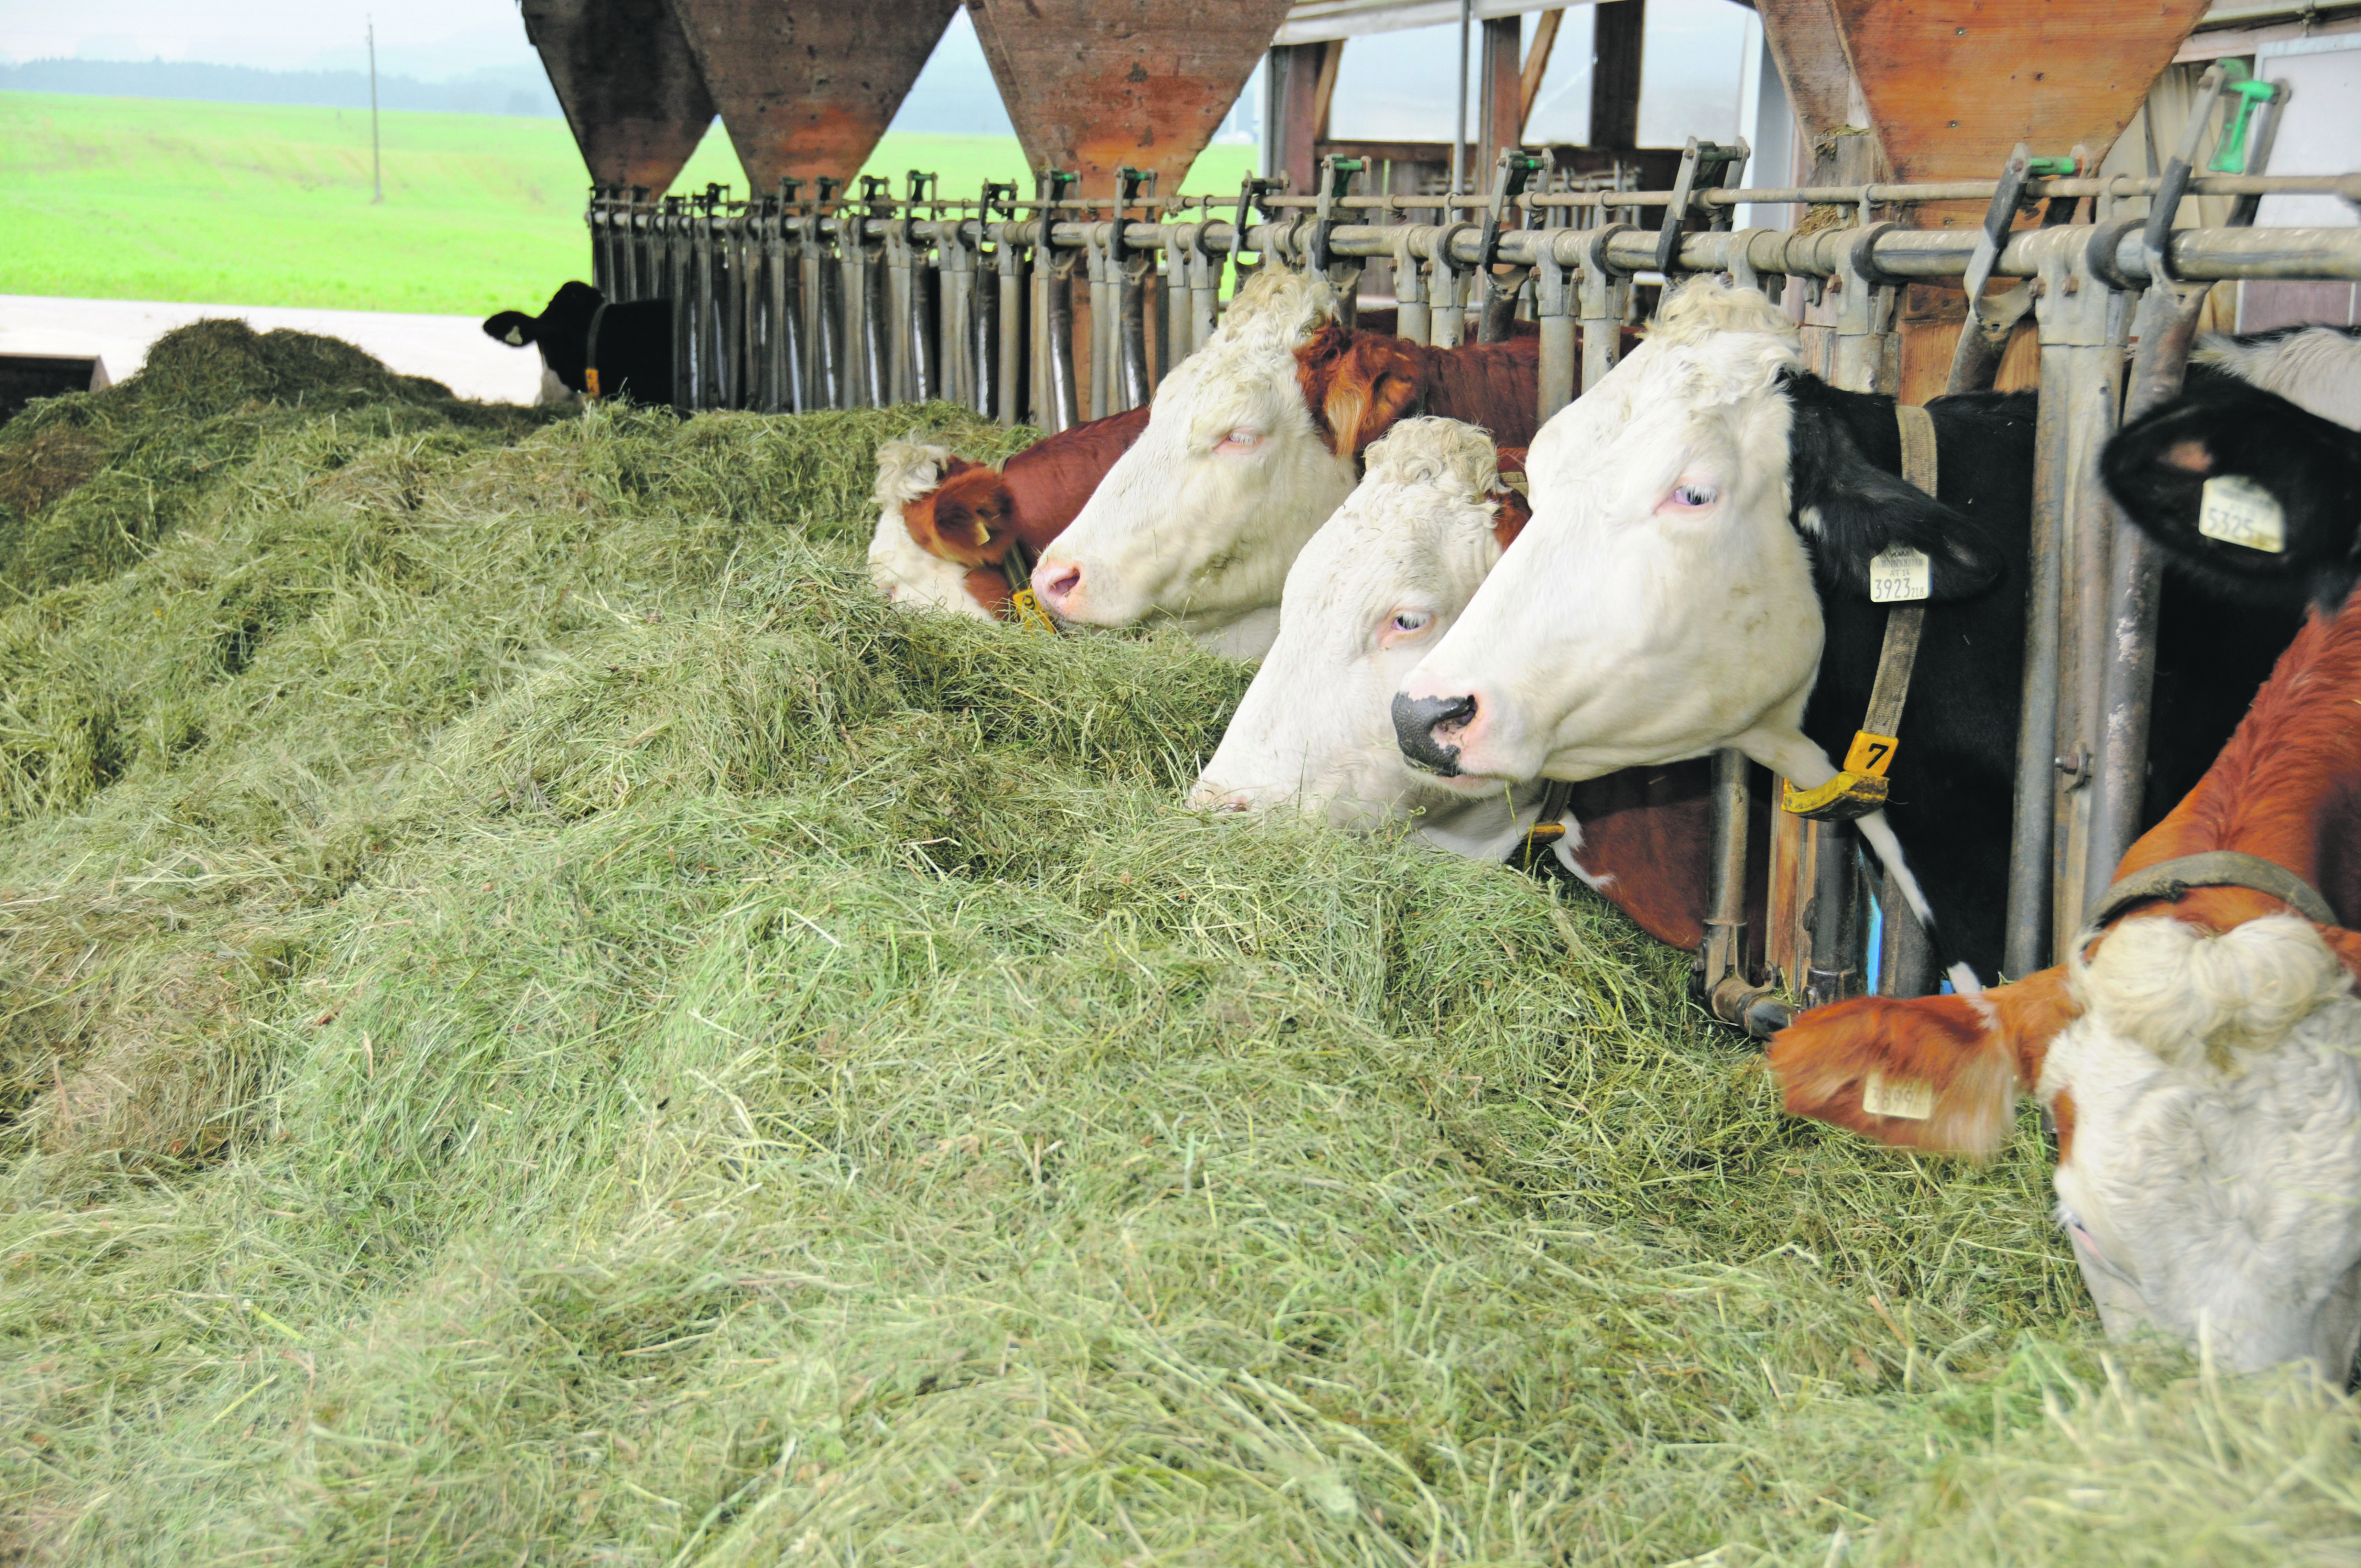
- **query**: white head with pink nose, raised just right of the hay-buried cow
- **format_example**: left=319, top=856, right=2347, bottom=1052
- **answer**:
left=1032, top=267, right=1360, bottom=659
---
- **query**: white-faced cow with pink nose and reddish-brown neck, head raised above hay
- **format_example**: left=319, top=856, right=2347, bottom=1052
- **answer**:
left=1032, top=269, right=1539, bottom=659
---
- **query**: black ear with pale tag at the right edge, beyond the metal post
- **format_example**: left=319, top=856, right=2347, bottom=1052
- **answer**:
left=2099, top=378, right=2361, bottom=614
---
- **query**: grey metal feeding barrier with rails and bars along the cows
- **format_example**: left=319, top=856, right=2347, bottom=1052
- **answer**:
left=590, top=66, right=2361, bottom=1032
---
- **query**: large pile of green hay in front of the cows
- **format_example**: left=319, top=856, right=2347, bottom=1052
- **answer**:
left=0, top=328, right=2361, bottom=1568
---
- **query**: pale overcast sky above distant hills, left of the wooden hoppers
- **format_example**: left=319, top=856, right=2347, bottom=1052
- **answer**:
left=0, top=0, right=538, bottom=80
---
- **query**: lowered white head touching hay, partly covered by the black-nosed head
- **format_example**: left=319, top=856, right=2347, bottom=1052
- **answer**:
left=1190, top=418, right=1542, bottom=859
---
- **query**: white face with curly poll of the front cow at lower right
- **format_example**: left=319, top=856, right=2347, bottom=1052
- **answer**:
left=2038, top=914, right=2361, bottom=1386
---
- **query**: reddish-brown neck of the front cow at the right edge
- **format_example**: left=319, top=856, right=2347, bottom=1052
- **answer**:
left=2118, top=578, right=2361, bottom=973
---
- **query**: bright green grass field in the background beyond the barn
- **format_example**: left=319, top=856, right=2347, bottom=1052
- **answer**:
left=0, top=92, right=1254, bottom=317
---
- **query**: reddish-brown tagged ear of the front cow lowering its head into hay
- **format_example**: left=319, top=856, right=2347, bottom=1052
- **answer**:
left=1769, top=997, right=2016, bottom=1157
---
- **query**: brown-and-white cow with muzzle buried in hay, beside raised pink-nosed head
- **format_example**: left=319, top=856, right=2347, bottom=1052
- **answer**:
left=869, top=409, right=1147, bottom=621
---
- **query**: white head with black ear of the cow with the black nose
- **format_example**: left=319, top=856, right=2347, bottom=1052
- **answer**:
left=1395, top=279, right=2002, bottom=786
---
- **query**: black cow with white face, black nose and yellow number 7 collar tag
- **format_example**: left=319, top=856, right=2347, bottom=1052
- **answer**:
left=1395, top=279, right=2323, bottom=989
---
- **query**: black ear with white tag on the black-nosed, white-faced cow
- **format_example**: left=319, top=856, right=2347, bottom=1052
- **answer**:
left=1789, top=401, right=2009, bottom=605
